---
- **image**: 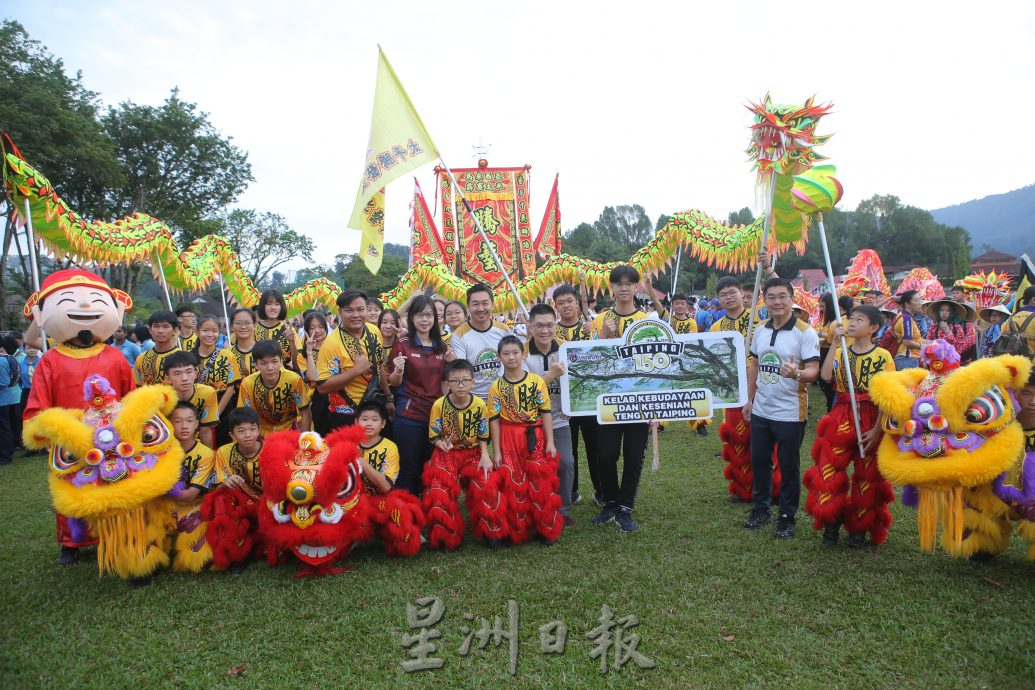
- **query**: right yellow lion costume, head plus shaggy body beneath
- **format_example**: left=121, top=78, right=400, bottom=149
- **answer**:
left=869, top=340, right=1035, bottom=560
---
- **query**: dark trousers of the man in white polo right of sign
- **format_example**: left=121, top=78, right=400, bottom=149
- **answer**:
left=751, top=414, right=805, bottom=518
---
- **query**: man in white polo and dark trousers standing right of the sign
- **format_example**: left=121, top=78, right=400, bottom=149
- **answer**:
left=743, top=278, right=820, bottom=539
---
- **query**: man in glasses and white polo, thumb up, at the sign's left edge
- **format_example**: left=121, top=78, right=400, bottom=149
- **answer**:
left=525, top=304, right=574, bottom=528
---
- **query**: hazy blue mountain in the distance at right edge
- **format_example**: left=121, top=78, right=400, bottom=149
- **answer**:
left=930, top=184, right=1035, bottom=257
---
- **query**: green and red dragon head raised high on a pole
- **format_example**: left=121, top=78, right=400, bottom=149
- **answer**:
left=747, top=93, right=833, bottom=175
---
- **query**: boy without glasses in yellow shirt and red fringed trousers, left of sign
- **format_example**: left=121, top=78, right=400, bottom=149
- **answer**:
left=489, top=335, right=564, bottom=544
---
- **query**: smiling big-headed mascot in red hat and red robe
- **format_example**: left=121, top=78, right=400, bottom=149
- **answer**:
left=24, top=270, right=135, bottom=565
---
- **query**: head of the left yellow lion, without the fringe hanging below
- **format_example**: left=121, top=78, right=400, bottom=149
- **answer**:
left=23, top=376, right=183, bottom=518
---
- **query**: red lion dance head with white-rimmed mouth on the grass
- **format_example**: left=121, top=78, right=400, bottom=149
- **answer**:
left=259, top=426, right=364, bottom=567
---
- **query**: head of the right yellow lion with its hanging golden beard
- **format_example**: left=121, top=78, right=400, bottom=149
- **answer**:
left=869, top=355, right=1032, bottom=549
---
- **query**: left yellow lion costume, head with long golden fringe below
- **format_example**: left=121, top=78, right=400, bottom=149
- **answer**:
left=23, top=378, right=183, bottom=579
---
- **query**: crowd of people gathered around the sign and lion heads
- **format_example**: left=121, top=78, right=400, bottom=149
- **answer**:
left=0, top=264, right=1035, bottom=563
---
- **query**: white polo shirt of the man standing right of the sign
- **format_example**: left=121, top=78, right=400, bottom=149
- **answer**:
left=751, top=317, right=820, bottom=422
